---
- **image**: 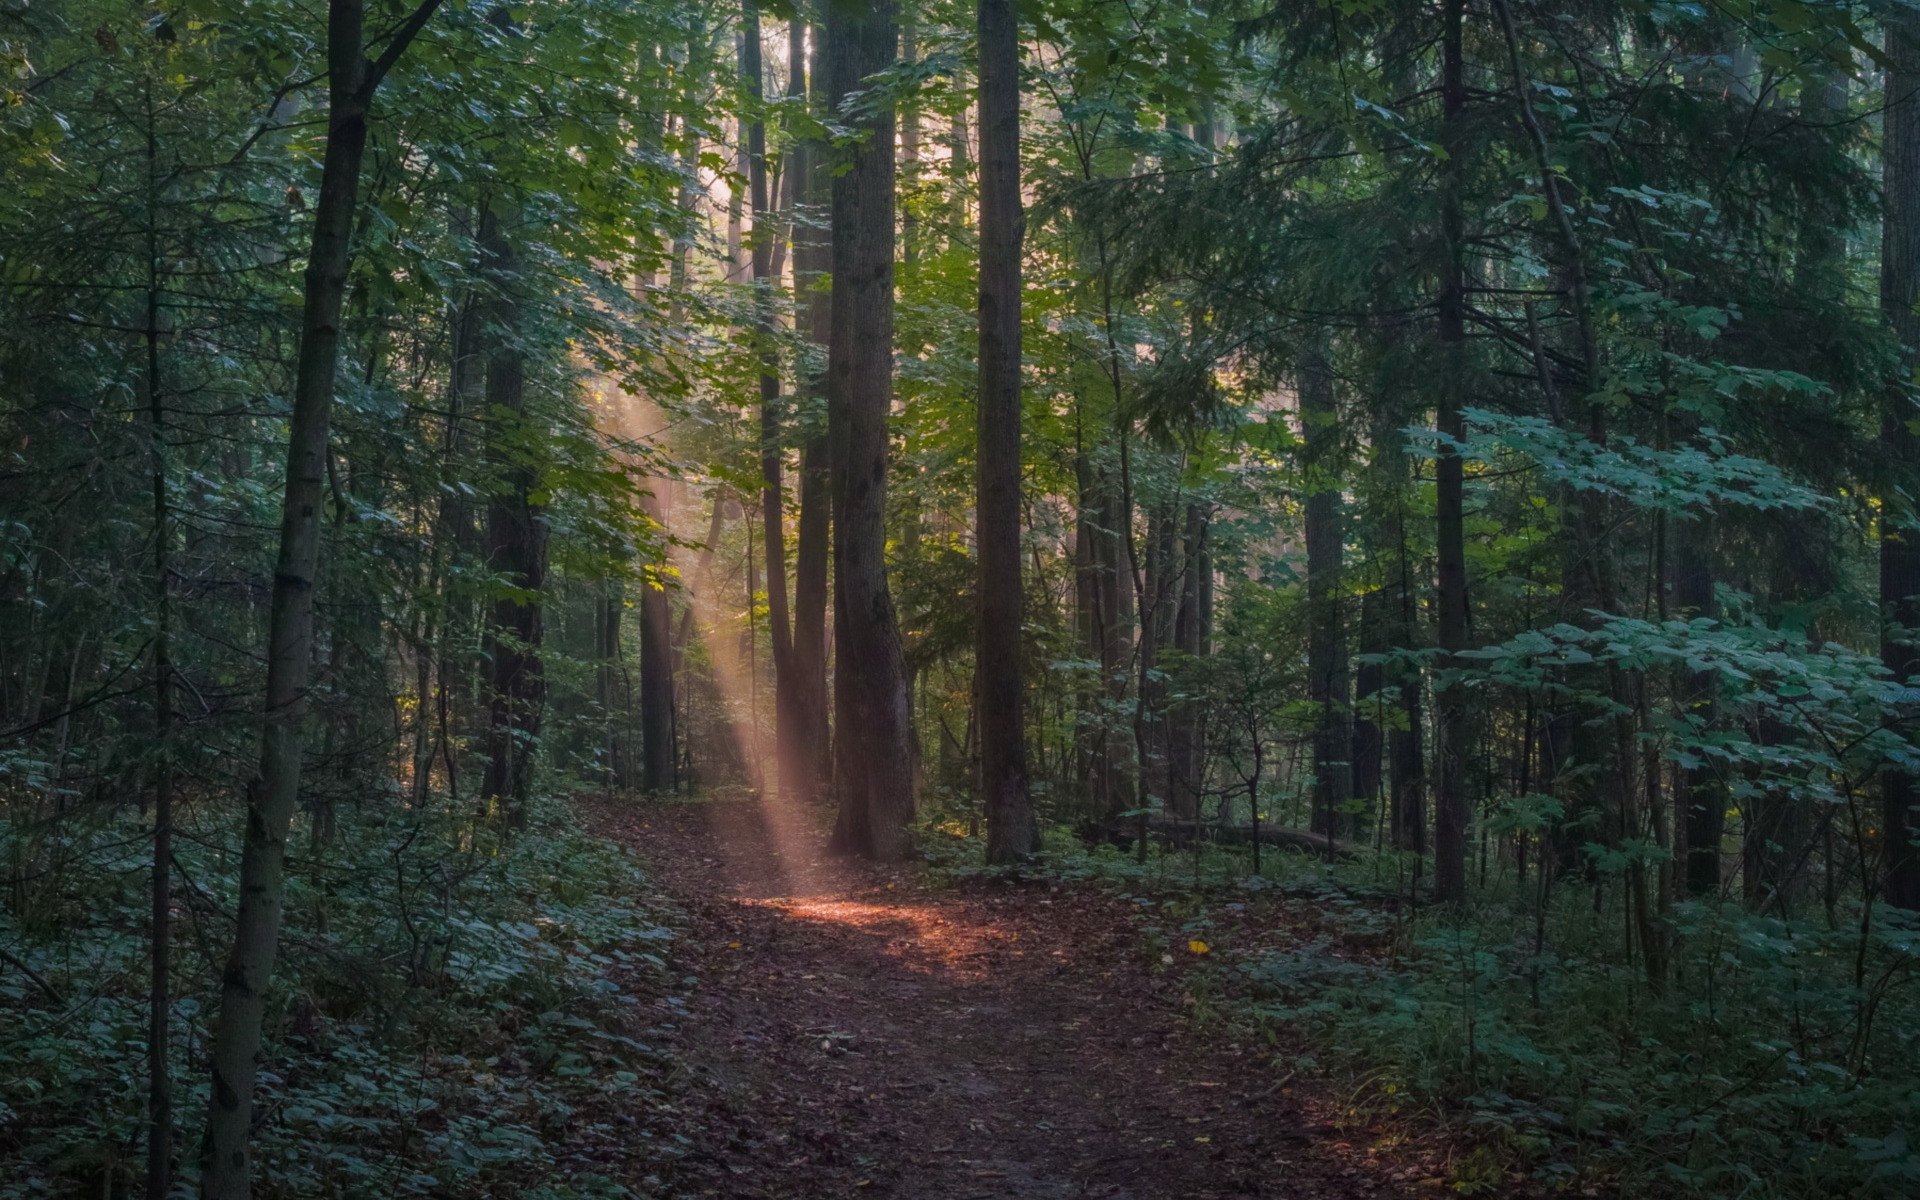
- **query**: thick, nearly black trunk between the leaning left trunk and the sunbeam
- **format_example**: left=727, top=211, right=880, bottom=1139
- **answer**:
left=480, top=204, right=547, bottom=829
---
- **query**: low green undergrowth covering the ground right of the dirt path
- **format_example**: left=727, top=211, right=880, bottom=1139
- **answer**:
left=927, top=829, right=1920, bottom=1200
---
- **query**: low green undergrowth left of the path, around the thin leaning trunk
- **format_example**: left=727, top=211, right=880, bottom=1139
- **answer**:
left=0, top=801, right=682, bottom=1200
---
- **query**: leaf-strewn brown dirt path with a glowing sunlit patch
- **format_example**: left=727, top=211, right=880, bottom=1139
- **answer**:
left=593, top=801, right=1425, bottom=1200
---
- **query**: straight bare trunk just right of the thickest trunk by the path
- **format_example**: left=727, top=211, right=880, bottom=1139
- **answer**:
left=975, top=0, right=1039, bottom=862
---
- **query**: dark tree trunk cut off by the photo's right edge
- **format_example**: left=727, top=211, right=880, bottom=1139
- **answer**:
left=1880, top=10, right=1920, bottom=910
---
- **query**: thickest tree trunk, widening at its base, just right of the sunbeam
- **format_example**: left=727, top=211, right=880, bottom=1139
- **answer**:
left=828, top=0, right=914, bottom=862
